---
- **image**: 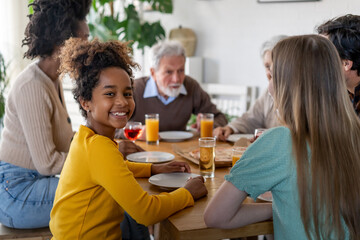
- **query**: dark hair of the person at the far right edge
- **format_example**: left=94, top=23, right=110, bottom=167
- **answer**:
left=316, top=14, right=360, bottom=76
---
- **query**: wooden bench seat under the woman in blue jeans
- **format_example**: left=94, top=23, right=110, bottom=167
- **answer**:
left=0, top=223, right=52, bottom=240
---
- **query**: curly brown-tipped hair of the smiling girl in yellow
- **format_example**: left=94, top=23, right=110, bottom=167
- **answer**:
left=59, top=38, right=140, bottom=118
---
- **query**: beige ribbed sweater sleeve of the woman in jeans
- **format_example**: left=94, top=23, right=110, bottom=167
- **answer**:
left=15, top=80, right=70, bottom=175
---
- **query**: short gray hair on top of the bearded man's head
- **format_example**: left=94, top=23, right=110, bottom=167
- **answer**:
left=150, top=40, right=186, bottom=70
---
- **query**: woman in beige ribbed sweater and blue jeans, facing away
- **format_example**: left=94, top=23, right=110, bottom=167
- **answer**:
left=0, top=0, right=91, bottom=228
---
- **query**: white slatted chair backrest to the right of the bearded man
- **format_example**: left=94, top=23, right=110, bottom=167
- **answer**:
left=202, top=83, right=259, bottom=116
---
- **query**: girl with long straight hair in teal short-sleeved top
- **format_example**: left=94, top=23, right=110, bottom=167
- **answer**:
left=204, top=35, right=360, bottom=239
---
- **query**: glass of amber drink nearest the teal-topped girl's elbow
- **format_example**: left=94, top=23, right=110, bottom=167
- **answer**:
left=199, top=137, right=216, bottom=178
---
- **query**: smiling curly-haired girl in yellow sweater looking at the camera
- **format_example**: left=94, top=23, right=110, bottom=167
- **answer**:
left=50, top=39, right=207, bottom=239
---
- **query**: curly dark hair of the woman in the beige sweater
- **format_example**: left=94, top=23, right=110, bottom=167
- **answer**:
left=22, top=0, right=92, bottom=59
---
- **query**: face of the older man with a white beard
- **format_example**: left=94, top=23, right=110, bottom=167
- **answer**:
left=150, top=56, right=185, bottom=97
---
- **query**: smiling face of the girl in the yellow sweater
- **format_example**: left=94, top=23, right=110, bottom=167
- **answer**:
left=81, top=67, right=135, bottom=139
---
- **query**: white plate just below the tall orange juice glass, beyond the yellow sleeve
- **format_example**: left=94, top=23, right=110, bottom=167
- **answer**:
left=126, top=152, right=175, bottom=163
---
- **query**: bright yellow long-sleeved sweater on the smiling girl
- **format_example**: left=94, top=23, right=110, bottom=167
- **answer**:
left=50, top=126, right=194, bottom=240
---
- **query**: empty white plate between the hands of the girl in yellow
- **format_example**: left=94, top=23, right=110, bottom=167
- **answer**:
left=149, top=173, right=200, bottom=189
